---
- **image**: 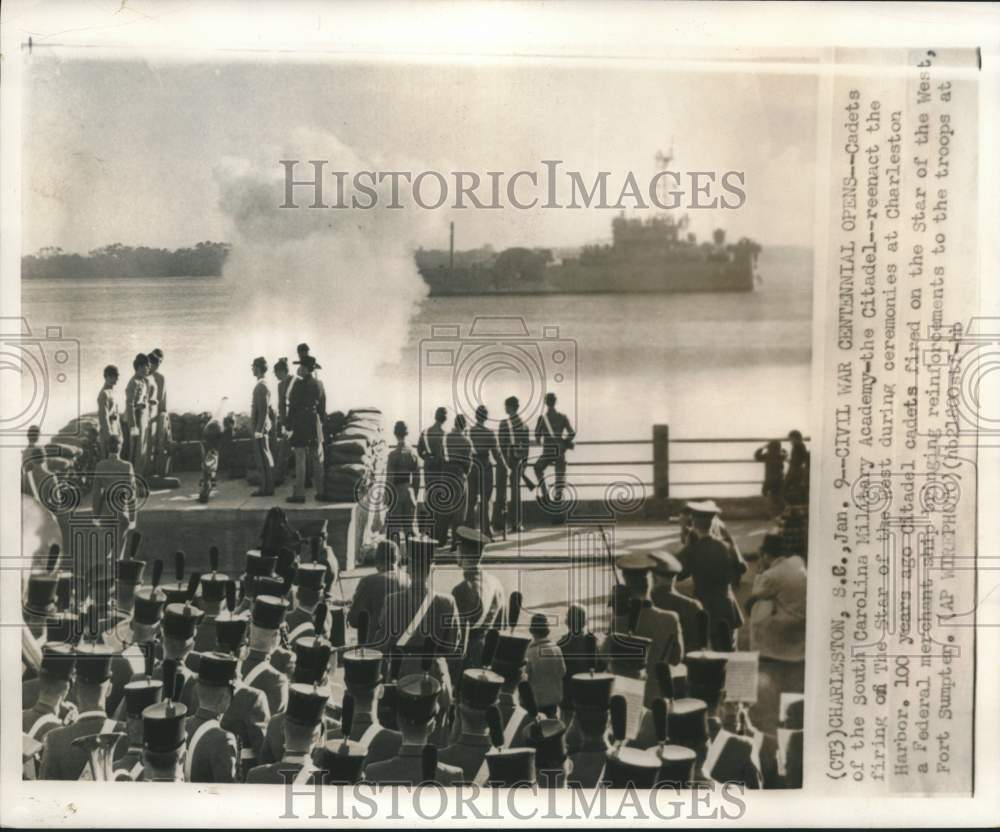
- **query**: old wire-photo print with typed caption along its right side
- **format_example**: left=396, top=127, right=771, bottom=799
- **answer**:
left=0, top=2, right=1000, bottom=826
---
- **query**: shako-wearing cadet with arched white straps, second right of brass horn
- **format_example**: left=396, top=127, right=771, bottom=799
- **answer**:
left=184, top=653, right=239, bottom=783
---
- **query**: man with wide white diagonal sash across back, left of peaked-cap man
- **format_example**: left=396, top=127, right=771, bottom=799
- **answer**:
left=372, top=537, right=459, bottom=736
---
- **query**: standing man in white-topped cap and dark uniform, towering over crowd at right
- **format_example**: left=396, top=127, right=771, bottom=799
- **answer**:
left=677, top=500, right=747, bottom=651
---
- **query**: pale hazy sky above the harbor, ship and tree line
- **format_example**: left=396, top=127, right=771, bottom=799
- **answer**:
left=22, top=51, right=817, bottom=253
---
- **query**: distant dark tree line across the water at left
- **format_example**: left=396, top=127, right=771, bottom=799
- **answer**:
left=21, top=240, right=231, bottom=278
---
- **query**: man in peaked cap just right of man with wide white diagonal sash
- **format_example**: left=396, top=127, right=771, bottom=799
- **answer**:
left=451, top=526, right=506, bottom=670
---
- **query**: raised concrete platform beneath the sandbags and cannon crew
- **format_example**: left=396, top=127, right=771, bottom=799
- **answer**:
left=125, top=473, right=368, bottom=580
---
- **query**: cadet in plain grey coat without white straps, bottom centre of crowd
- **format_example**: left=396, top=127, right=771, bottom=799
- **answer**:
left=365, top=673, right=463, bottom=786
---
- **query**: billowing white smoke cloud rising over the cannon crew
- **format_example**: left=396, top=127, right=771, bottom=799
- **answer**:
left=209, top=129, right=435, bottom=410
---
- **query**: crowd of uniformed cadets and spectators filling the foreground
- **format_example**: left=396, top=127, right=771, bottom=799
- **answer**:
left=23, top=504, right=802, bottom=788
